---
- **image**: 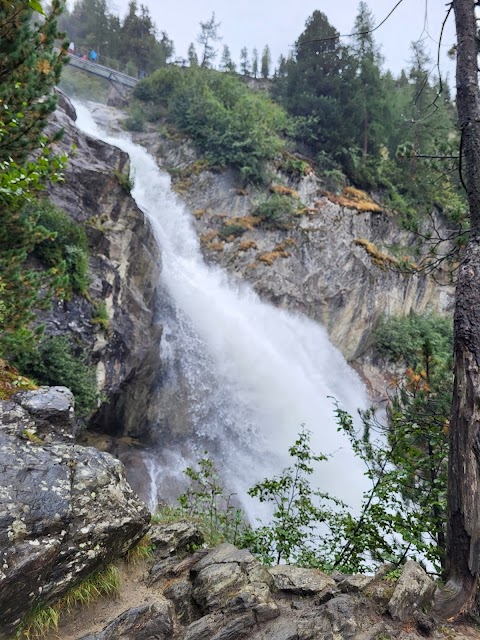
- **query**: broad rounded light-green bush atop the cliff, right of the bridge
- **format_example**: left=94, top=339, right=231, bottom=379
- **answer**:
left=134, top=67, right=287, bottom=182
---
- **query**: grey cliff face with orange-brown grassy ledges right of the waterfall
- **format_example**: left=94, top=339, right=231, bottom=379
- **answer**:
left=132, top=129, right=452, bottom=361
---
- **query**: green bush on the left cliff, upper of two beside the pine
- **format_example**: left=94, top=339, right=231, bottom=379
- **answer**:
left=28, top=200, right=88, bottom=293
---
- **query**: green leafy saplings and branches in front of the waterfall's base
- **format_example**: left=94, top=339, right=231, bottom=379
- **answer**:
left=171, top=315, right=452, bottom=577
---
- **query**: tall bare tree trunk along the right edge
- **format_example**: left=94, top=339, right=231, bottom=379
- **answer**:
left=435, top=0, right=480, bottom=617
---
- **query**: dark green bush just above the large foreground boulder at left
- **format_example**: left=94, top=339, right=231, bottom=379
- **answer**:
left=14, top=336, right=98, bottom=418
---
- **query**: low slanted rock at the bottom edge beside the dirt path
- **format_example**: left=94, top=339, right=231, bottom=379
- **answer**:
left=80, top=602, right=173, bottom=640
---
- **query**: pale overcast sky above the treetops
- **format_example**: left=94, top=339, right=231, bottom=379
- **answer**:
left=110, top=0, right=454, bottom=83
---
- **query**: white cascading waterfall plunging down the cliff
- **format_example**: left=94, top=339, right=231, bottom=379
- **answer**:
left=76, top=105, right=367, bottom=517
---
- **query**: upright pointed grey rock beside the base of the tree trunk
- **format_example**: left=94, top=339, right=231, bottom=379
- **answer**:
left=388, top=560, right=436, bottom=622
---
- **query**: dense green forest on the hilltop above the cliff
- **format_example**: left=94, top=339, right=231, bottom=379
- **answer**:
left=60, top=0, right=465, bottom=228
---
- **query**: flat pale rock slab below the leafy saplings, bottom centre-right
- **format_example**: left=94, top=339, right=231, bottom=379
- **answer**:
left=269, top=565, right=338, bottom=598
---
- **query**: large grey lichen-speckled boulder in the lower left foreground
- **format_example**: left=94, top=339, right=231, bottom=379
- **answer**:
left=0, top=388, right=149, bottom=638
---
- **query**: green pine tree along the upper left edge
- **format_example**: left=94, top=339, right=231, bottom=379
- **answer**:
left=0, top=0, right=66, bottom=356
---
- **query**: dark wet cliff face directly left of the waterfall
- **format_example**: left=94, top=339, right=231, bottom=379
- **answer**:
left=47, top=98, right=161, bottom=433
